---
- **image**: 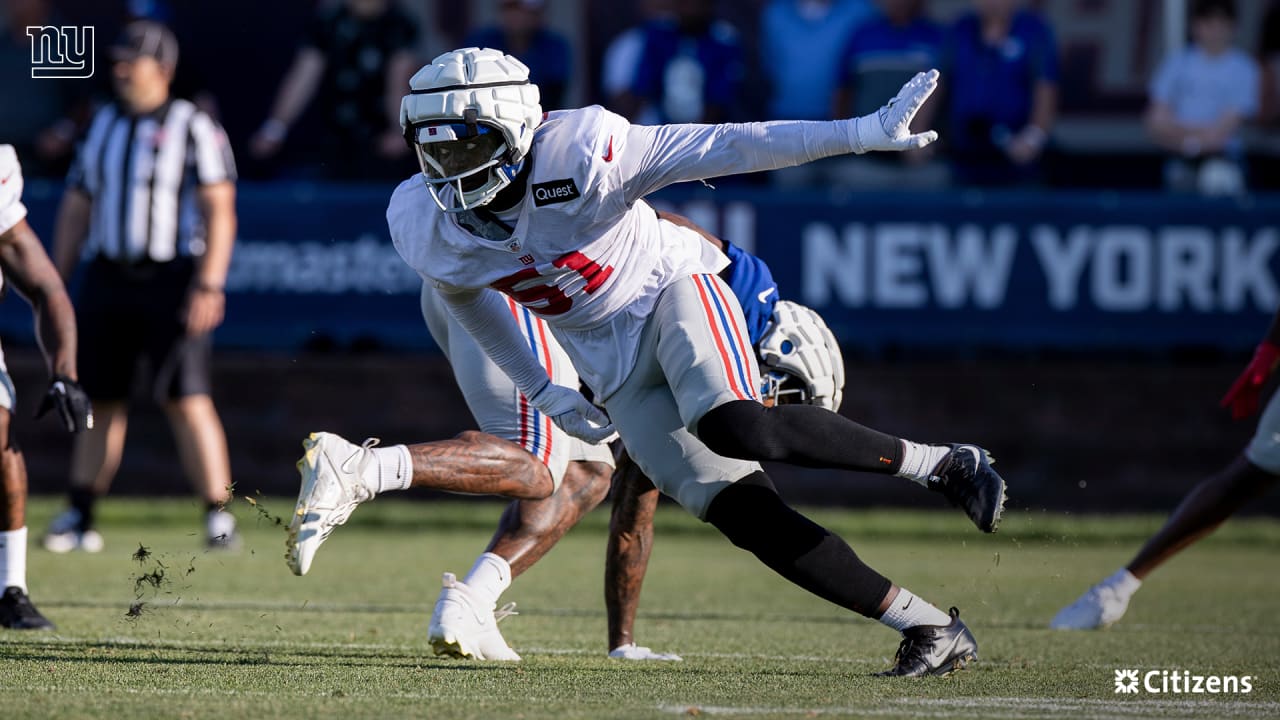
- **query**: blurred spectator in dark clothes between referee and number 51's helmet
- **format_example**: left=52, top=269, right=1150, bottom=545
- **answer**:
left=250, top=0, right=419, bottom=179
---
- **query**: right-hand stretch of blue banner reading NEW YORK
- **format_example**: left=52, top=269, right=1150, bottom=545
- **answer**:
left=650, top=191, right=1280, bottom=350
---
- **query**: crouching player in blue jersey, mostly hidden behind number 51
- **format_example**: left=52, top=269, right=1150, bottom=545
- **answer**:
left=289, top=204, right=844, bottom=660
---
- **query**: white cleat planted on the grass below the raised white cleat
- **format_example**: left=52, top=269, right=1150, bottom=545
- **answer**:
left=426, top=573, right=520, bottom=660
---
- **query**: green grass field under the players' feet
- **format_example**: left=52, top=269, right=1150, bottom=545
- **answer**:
left=0, top=491, right=1280, bottom=720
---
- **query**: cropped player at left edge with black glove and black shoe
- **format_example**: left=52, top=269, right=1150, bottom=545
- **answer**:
left=0, top=145, right=93, bottom=630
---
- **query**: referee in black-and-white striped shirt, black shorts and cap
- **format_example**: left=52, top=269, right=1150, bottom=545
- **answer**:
left=45, top=20, right=237, bottom=552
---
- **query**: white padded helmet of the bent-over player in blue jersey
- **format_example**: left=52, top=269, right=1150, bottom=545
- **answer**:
left=758, top=300, right=845, bottom=411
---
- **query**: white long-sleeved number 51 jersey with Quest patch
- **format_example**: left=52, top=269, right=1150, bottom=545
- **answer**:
left=387, top=106, right=854, bottom=396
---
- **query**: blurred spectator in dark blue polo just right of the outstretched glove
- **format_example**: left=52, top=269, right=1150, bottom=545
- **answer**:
left=942, top=0, right=1059, bottom=186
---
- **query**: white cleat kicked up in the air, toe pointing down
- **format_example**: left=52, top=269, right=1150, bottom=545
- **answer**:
left=284, top=433, right=378, bottom=575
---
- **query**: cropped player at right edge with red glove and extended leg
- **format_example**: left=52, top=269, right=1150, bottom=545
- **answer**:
left=1050, top=311, right=1280, bottom=630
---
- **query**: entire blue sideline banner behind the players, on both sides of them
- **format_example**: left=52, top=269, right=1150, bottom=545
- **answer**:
left=10, top=183, right=1280, bottom=351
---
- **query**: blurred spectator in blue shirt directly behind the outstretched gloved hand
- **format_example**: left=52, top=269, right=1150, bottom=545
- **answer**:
left=832, top=0, right=947, bottom=190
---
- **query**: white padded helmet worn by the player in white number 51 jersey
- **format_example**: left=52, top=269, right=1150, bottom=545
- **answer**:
left=401, top=47, right=543, bottom=213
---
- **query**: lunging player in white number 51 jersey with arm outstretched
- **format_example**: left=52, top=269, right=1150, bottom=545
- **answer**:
left=387, top=47, right=1005, bottom=675
